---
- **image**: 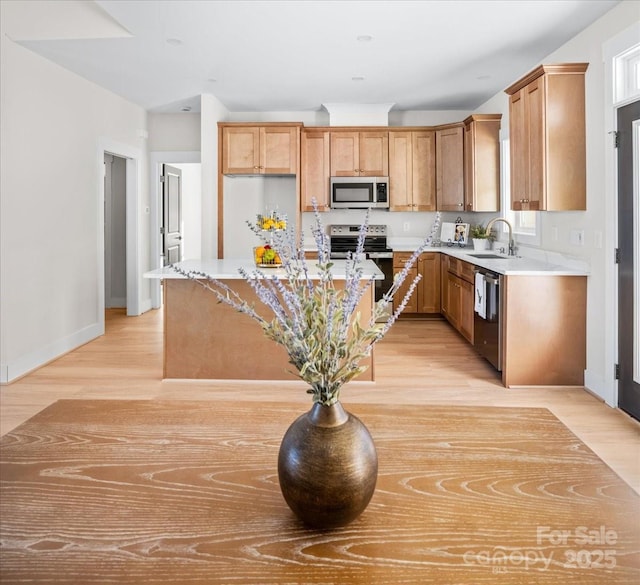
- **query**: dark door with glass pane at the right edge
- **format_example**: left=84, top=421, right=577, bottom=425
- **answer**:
left=618, top=101, right=640, bottom=419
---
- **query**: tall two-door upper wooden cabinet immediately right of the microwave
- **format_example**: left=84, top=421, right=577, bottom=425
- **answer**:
left=389, top=130, right=436, bottom=211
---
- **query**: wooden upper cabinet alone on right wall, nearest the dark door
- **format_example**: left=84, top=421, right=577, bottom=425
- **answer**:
left=505, top=63, right=589, bottom=211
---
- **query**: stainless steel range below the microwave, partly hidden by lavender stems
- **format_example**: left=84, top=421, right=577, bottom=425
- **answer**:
left=329, top=225, right=393, bottom=301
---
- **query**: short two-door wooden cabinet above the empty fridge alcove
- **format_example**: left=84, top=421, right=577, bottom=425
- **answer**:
left=220, top=123, right=301, bottom=175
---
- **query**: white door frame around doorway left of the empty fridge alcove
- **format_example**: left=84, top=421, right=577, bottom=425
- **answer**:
left=149, top=150, right=202, bottom=309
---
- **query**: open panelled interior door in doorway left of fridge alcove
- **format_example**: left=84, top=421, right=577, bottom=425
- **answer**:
left=160, top=165, right=182, bottom=266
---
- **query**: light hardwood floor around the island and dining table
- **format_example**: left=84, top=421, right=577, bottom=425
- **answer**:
left=0, top=310, right=640, bottom=493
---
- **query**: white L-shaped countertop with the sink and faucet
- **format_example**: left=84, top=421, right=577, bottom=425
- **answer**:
left=389, top=239, right=589, bottom=276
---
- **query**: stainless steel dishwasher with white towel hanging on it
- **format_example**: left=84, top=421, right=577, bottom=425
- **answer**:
left=473, top=269, right=502, bottom=372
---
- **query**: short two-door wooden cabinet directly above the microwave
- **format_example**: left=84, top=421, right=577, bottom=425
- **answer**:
left=330, top=130, right=389, bottom=177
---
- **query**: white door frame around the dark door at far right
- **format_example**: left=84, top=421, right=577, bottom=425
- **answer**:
left=600, top=23, right=640, bottom=408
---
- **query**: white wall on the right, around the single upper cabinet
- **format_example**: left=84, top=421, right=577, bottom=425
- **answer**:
left=478, top=0, right=640, bottom=406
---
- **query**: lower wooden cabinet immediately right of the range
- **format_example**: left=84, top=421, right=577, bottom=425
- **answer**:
left=393, top=252, right=441, bottom=314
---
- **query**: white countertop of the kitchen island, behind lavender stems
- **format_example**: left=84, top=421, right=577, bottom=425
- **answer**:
left=143, top=258, right=384, bottom=280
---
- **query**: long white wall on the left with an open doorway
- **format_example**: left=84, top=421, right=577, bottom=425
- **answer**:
left=0, top=2, right=149, bottom=382
